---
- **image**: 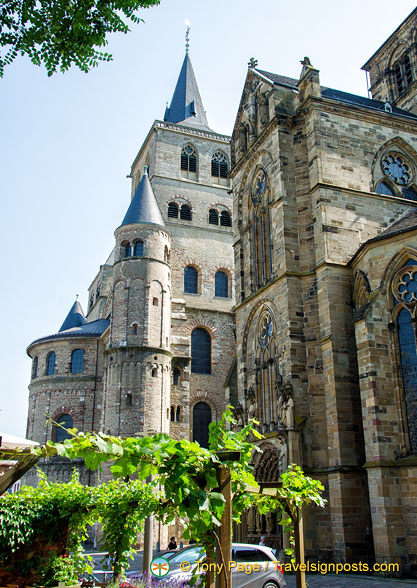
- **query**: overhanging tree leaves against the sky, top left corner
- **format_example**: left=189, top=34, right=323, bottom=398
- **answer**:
left=0, top=0, right=159, bottom=77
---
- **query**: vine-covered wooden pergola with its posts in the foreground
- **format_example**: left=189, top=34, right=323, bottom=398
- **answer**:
left=0, top=408, right=325, bottom=588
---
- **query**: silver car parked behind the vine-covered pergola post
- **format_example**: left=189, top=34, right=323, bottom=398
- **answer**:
left=161, top=543, right=287, bottom=588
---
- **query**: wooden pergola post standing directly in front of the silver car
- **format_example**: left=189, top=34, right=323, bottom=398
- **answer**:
left=216, top=466, right=232, bottom=588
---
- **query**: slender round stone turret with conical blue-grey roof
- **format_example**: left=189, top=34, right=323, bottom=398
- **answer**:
left=103, top=168, right=171, bottom=436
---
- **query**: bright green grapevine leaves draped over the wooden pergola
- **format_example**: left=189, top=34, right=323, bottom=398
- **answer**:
left=0, top=407, right=325, bottom=579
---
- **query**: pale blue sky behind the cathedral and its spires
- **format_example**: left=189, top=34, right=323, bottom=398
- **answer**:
left=0, top=0, right=415, bottom=435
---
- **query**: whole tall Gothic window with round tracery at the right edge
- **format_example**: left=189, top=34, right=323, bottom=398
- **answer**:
left=392, top=259, right=417, bottom=452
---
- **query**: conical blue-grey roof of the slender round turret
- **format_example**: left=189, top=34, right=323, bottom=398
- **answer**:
left=121, top=167, right=165, bottom=227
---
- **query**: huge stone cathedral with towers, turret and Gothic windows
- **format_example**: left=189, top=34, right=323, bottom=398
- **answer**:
left=27, top=9, right=417, bottom=574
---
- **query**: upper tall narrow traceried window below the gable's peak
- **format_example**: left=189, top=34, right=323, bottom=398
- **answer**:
left=250, top=168, right=272, bottom=290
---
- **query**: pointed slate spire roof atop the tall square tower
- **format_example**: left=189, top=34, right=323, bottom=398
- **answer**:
left=164, top=53, right=209, bottom=130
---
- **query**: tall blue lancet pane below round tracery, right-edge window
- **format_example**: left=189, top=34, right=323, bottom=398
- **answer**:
left=397, top=306, right=417, bottom=451
